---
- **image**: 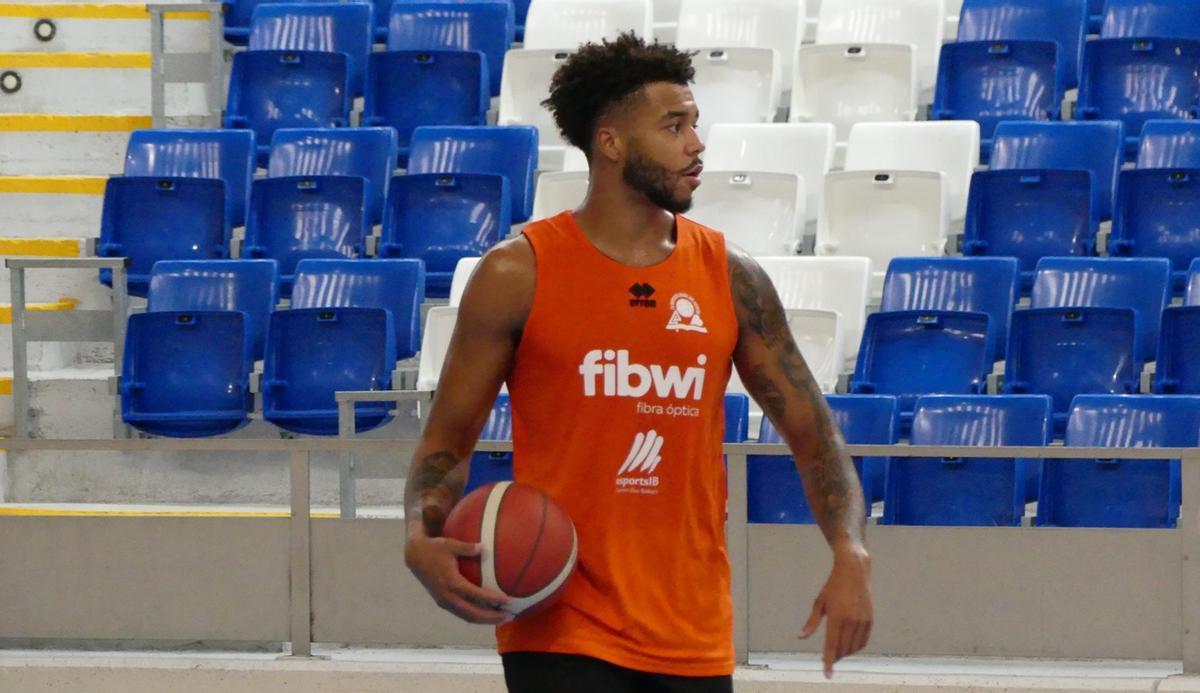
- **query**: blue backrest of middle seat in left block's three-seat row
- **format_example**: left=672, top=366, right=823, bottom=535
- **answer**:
left=266, top=127, right=396, bottom=224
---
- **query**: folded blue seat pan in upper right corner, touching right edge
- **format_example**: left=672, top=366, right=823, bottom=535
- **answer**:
left=1075, top=38, right=1200, bottom=159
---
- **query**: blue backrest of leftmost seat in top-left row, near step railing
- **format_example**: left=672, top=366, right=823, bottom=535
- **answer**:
left=250, top=2, right=374, bottom=98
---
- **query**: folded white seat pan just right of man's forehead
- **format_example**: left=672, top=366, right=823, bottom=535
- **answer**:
left=691, top=48, right=779, bottom=138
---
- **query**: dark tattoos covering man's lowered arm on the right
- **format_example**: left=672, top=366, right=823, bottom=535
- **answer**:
left=730, top=251, right=865, bottom=544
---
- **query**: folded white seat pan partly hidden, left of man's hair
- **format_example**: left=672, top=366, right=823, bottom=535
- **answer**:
left=496, top=48, right=571, bottom=146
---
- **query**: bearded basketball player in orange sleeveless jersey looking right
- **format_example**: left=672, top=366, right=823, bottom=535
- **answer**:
left=406, top=35, right=872, bottom=693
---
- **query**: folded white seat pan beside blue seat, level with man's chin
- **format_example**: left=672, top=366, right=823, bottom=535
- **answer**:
left=816, top=170, right=949, bottom=299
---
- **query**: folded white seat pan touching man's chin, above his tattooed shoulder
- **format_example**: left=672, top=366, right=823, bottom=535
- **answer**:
left=686, top=170, right=804, bottom=255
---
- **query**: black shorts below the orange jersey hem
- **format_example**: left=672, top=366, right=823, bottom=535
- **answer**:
left=500, top=652, right=733, bottom=693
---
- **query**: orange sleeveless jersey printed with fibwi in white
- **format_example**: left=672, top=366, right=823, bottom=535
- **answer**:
left=497, top=212, right=737, bottom=676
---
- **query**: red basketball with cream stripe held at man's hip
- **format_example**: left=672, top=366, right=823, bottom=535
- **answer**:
left=443, top=481, right=578, bottom=615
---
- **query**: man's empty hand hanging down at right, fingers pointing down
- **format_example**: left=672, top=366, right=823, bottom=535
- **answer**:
left=800, top=544, right=874, bottom=679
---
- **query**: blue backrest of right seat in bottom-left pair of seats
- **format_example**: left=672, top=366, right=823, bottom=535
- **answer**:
left=292, top=260, right=425, bottom=358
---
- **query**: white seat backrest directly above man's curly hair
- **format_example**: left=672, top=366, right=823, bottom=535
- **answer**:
left=524, top=0, right=654, bottom=50
